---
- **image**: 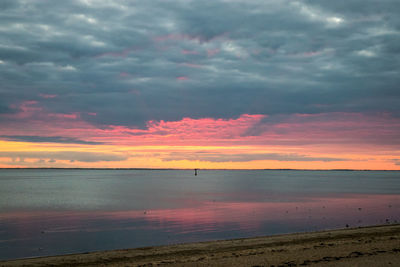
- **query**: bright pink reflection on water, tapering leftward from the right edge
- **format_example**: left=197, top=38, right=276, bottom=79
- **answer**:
left=106, top=195, right=400, bottom=230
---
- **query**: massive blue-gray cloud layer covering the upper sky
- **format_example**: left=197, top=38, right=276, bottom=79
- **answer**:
left=0, top=0, right=400, bottom=127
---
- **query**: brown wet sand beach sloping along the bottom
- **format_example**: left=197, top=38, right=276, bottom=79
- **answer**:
left=0, top=224, right=400, bottom=267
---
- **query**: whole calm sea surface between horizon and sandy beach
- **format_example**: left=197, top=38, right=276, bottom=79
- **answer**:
left=0, top=169, right=400, bottom=260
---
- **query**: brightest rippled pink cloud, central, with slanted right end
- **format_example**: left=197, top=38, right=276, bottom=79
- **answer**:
left=53, top=114, right=265, bottom=145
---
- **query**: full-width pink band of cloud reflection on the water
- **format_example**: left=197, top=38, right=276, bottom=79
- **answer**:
left=0, top=195, right=400, bottom=233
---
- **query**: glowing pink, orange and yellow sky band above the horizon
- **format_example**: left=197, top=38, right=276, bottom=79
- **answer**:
left=0, top=101, right=400, bottom=169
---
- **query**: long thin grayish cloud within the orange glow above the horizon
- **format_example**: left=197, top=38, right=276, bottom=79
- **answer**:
left=162, top=152, right=348, bottom=162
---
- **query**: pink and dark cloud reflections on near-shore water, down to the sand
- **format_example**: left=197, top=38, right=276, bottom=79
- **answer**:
left=0, top=194, right=400, bottom=258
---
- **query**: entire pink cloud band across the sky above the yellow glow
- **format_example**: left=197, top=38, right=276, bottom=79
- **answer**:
left=0, top=105, right=400, bottom=153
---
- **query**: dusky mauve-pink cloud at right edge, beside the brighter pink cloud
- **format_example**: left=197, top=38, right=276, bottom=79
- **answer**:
left=244, top=112, right=400, bottom=148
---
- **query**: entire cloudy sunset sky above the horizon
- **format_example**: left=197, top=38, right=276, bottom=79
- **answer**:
left=0, top=0, right=400, bottom=170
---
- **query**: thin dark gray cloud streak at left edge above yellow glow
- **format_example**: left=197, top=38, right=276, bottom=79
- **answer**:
left=0, top=135, right=102, bottom=145
